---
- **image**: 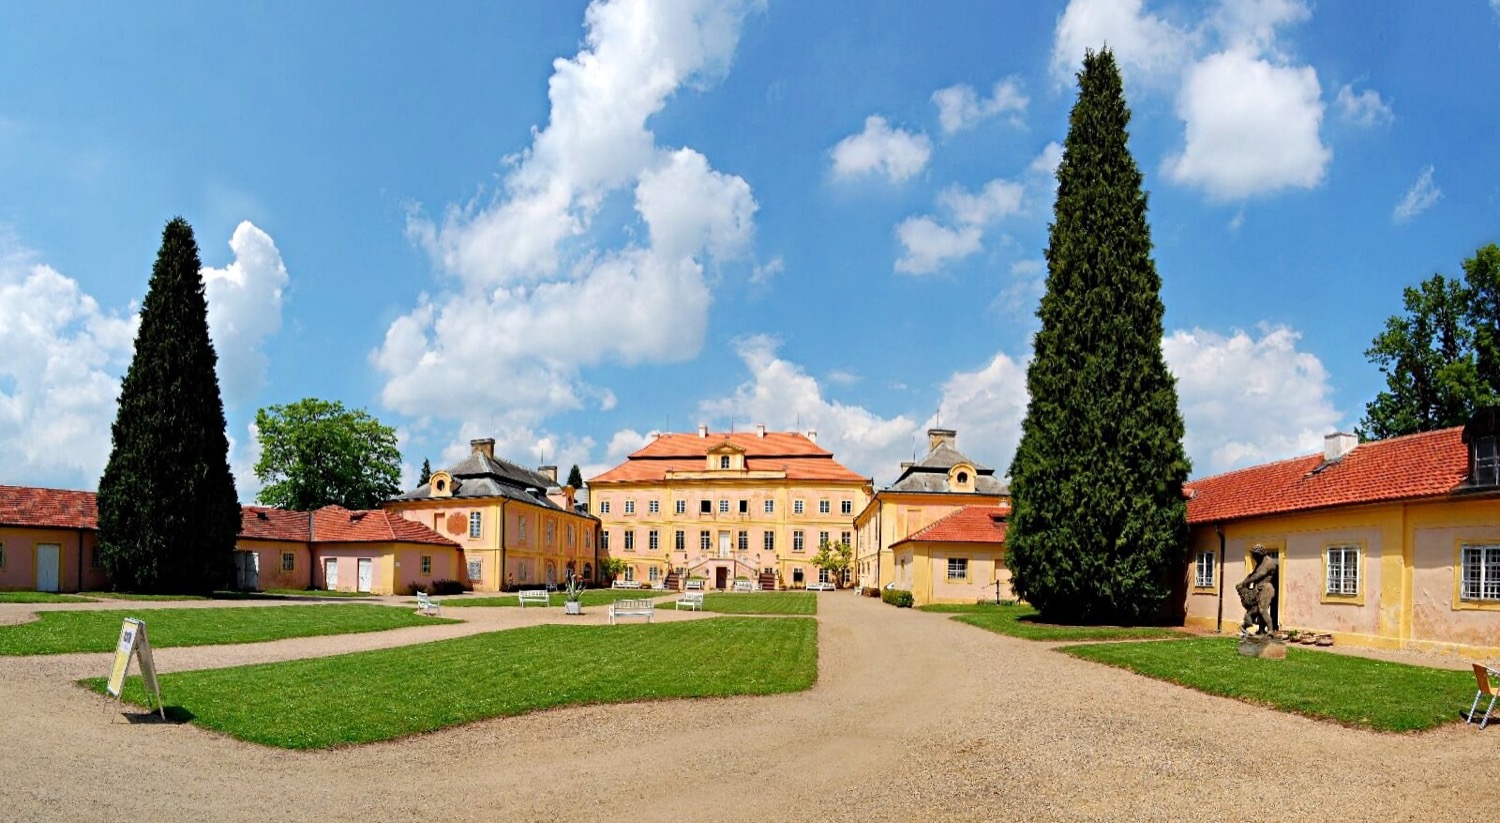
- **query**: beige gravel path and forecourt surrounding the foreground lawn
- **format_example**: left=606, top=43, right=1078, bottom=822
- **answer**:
left=0, top=592, right=1500, bottom=823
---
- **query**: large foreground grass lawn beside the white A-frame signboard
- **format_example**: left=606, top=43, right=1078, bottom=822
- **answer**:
left=83, top=618, right=818, bottom=748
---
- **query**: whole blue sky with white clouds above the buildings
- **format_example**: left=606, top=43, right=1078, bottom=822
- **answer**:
left=0, top=0, right=1500, bottom=501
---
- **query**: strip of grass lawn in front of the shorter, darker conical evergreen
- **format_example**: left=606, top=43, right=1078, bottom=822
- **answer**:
left=0, top=604, right=455, bottom=655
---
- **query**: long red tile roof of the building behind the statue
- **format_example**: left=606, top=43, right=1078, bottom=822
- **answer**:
left=1185, top=427, right=1469, bottom=523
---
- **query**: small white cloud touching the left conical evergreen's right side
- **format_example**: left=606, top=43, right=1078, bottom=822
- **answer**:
left=203, top=220, right=288, bottom=405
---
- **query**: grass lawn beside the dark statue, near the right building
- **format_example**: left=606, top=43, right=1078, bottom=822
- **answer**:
left=1059, top=637, right=1475, bottom=732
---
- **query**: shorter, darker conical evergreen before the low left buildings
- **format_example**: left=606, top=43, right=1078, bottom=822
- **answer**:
left=99, top=217, right=240, bottom=594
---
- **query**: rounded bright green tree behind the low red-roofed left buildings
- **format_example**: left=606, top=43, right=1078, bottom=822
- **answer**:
left=255, top=397, right=401, bottom=511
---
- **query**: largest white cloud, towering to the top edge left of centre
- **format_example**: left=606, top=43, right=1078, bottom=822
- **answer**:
left=381, top=0, right=762, bottom=433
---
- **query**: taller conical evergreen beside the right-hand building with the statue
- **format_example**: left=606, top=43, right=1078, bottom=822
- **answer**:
left=1007, top=49, right=1188, bottom=622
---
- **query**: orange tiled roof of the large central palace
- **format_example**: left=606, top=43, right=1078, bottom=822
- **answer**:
left=588, top=432, right=866, bottom=486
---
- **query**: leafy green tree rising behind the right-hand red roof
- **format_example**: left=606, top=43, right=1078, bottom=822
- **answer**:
left=1358, top=243, right=1500, bottom=439
